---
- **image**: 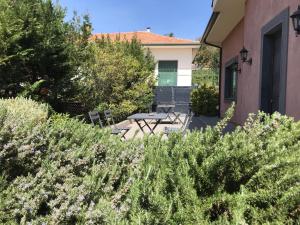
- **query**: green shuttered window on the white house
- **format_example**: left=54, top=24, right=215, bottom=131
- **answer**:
left=158, top=61, right=177, bottom=86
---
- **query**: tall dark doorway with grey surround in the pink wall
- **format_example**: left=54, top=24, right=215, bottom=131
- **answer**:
left=261, top=10, right=289, bottom=114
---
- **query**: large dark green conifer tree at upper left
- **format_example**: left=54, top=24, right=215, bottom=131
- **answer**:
left=0, top=0, right=90, bottom=102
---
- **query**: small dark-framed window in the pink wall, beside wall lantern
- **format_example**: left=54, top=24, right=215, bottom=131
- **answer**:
left=224, top=61, right=237, bottom=100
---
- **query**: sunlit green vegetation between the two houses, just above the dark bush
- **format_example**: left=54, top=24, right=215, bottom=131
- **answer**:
left=192, top=69, right=219, bottom=87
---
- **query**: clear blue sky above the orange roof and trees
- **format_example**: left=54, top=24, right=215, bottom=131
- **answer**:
left=58, top=0, right=211, bottom=39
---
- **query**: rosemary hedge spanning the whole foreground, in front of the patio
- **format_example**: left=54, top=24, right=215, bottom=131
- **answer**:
left=0, top=99, right=300, bottom=224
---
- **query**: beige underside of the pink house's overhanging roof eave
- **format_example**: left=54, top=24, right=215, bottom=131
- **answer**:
left=201, top=0, right=246, bottom=47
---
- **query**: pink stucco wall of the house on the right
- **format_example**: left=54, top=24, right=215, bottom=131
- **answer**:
left=221, top=0, right=300, bottom=124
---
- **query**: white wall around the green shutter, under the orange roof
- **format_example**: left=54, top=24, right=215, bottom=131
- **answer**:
left=149, top=47, right=194, bottom=86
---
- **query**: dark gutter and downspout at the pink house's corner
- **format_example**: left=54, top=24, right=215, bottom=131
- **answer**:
left=201, top=12, right=223, bottom=117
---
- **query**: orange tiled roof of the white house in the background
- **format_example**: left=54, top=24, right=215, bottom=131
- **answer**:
left=91, top=31, right=200, bottom=46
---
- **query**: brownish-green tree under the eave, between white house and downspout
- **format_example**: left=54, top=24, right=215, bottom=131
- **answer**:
left=194, top=44, right=220, bottom=71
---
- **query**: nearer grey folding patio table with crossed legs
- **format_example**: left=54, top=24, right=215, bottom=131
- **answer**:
left=127, top=113, right=168, bottom=134
